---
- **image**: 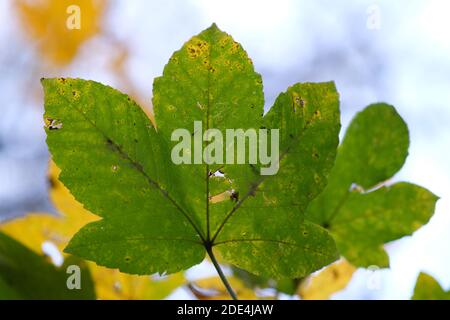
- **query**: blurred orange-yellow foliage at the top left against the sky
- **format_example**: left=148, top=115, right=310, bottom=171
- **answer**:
left=14, top=0, right=107, bottom=66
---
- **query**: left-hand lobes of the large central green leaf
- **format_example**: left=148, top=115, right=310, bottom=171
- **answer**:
left=43, top=79, right=204, bottom=274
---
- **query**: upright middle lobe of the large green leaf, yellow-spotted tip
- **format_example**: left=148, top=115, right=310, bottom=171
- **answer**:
left=153, top=25, right=264, bottom=234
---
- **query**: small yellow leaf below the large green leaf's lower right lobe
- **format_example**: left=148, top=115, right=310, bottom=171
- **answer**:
left=299, top=260, right=356, bottom=300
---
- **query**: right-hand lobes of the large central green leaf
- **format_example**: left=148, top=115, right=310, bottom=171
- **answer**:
left=215, top=83, right=340, bottom=278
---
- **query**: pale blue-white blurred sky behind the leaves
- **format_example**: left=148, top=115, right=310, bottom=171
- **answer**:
left=0, top=0, right=450, bottom=299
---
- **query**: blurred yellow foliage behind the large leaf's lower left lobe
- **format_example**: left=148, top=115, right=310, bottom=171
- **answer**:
left=0, top=163, right=185, bottom=300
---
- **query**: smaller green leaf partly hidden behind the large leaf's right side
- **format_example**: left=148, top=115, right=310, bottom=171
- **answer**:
left=307, top=103, right=437, bottom=267
